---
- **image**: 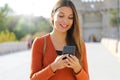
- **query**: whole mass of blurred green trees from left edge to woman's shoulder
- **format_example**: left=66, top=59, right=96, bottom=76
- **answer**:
left=0, top=4, right=52, bottom=41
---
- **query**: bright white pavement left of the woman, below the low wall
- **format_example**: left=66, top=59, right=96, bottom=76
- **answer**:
left=0, top=50, right=30, bottom=80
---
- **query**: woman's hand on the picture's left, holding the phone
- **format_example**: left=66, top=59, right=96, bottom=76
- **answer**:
left=51, top=54, right=67, bottom=72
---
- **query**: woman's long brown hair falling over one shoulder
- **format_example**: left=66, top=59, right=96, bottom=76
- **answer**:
left=52, top=0, right=83, bottom=61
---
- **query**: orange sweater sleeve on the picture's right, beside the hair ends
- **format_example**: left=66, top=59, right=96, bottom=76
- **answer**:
left=76, top=43, right=90, bottom=80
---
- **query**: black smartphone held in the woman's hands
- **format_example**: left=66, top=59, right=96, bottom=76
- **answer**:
left=62, top=46, right=76, bottom=59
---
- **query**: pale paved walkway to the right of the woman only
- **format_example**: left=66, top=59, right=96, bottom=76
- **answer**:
left=87, top=43, right=120, bottom=80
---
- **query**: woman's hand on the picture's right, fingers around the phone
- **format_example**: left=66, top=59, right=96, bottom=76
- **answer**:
left=65, top=55, right=82, bottom=73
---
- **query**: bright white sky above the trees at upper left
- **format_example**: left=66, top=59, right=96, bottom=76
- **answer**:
left=0, top=0, right=56, bottom=18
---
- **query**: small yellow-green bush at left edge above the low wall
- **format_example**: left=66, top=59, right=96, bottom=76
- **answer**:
left=0, top=30, right=17, bottom=43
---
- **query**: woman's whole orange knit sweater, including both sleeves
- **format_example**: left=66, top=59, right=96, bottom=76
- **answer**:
left=30, top=35, right=89, bottom=80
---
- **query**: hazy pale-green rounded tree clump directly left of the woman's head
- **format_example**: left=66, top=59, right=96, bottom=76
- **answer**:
left=13, top=16, right=51, bottom=40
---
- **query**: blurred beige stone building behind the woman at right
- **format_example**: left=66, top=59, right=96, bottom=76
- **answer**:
left=73, top=0, right=119, bottom=42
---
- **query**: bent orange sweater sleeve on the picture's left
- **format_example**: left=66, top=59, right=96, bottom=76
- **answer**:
left=30, top=38, right=54, bottom=80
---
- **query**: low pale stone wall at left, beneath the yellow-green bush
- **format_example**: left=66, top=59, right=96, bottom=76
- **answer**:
left=0, top=42, right=27, bottom=54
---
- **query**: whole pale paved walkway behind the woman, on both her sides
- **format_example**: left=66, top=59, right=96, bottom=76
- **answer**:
left=0, top=43, right=120, bottom=80
